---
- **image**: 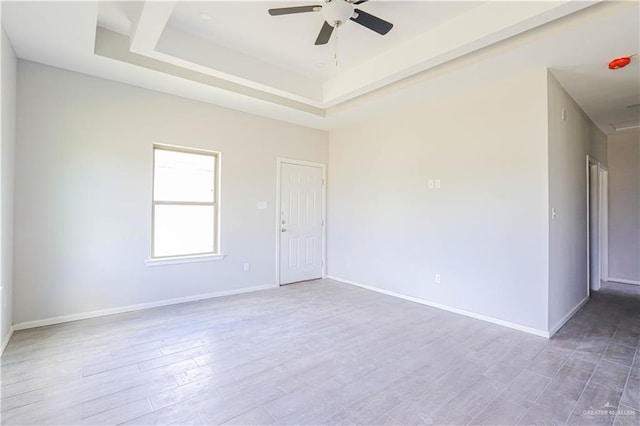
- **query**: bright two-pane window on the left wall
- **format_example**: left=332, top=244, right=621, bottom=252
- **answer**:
left=151, top=145, right=218, bottom=259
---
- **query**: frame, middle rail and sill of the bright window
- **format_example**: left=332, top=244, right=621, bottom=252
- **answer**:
left=146, top=144, right=224, bottom=266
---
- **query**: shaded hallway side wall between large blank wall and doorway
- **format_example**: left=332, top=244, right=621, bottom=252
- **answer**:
left=548, top=74, right=606, bottom=328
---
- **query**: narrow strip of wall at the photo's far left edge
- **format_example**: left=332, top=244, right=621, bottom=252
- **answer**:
left=0, top=24, right=17, bottom=342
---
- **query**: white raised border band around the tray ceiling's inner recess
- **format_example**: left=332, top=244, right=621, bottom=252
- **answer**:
left=124, top=0, right=598, bottom=108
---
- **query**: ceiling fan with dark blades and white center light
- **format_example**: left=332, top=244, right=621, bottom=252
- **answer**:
left=269, top=0, right=393, bottom=46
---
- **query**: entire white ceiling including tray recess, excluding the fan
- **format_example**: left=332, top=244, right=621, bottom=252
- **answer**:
left=2, top=0, right=640, bottom=132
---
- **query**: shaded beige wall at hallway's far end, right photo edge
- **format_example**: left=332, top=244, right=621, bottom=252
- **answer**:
left=607, top=131, right=640, bottom=284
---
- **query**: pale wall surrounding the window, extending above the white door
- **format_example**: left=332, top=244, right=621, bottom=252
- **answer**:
left=14, top=60, right=328, bottom=323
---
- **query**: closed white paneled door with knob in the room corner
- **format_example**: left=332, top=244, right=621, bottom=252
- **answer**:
left=280, top=163, right=323, bottom=284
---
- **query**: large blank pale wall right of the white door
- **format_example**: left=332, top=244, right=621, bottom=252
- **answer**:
left=327, top=69, right=549, bottom=330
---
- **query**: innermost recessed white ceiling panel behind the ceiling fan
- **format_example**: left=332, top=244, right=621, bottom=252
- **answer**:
left=168, top=0, right=483, bottom=82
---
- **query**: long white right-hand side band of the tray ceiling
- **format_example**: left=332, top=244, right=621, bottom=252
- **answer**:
left=323, top=0, right=599, bottom=108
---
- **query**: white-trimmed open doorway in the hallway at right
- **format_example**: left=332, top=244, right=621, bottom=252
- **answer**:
left=587, top=156, right=609, bottom=292
